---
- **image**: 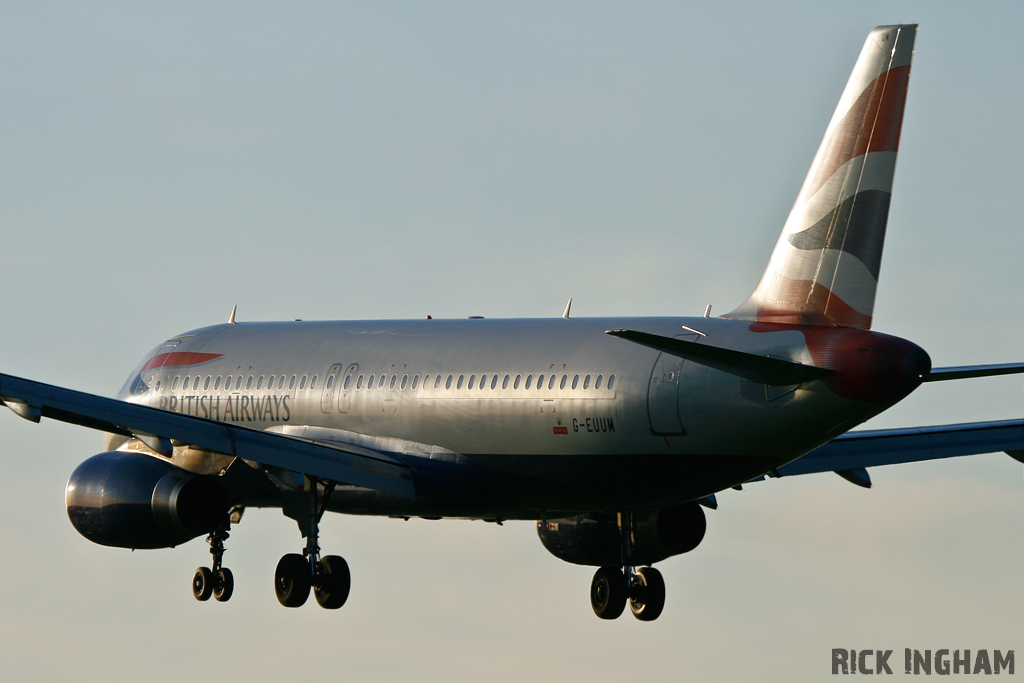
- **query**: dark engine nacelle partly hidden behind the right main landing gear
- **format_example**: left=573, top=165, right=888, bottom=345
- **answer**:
left=537, top=503, right=708, bottom=566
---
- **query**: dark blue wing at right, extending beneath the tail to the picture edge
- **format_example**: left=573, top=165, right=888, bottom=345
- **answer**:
left=769, top=420, right=1024, bottom=486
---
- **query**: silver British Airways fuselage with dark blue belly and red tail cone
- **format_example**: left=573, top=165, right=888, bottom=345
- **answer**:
left=120, top=317, right=923, bottom=518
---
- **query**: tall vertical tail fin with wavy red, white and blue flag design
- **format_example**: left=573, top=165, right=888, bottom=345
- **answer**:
left=724, top=24, right=918, bottom=330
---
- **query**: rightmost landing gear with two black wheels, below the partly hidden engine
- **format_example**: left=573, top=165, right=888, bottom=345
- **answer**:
left=590, top=512, right=665, bottom=622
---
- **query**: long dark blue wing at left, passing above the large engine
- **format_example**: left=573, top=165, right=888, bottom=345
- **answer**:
left=0, top=374, right=416, bottom=500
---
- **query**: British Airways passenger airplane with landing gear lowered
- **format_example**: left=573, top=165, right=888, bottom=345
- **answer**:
left=0, top=25, right=1024, bottom=621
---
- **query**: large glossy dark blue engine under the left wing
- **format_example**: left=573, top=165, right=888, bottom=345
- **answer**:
left=65, top=451, right=229, bottom=548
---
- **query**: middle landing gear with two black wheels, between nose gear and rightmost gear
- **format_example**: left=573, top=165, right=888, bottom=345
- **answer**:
left=273, top=478, right=352, bottom=609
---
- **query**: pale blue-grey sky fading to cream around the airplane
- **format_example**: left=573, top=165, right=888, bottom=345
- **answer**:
left=0, top=1, right=1024, bottom=681
